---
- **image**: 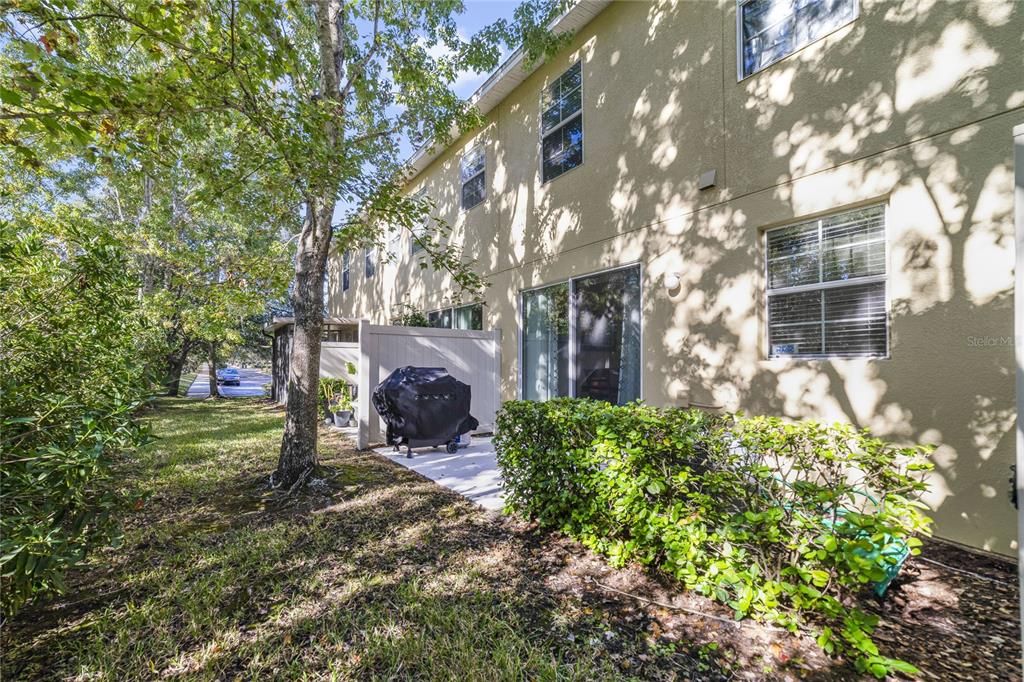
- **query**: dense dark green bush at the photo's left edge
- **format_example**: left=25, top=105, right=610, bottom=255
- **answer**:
left=0, top=213, right=151, bottom=614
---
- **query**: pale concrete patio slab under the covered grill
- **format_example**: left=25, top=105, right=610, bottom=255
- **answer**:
left=374, top=437, right=504, bottom=510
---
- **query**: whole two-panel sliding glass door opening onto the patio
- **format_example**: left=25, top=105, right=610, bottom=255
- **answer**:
left=522, top=265, right=640, bottom=404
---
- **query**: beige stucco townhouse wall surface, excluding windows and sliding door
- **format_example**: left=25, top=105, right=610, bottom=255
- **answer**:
left=330, top=0, right=1024, bottom=553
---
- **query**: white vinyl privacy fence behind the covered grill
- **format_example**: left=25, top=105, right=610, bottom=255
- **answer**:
left=321, top=321, right=501, bottom=450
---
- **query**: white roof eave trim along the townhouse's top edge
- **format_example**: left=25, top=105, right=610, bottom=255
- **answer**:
left=408, top=0, right=611, bottom=179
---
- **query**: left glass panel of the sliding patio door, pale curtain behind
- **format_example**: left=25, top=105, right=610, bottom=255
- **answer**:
left=522, top=284, right=569, bottom=400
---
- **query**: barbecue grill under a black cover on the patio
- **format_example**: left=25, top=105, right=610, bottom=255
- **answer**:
left=373, top=367, right=479, bottom=446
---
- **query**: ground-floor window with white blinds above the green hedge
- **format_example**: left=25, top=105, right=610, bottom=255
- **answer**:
left=766, top=206, right=889, bottom=357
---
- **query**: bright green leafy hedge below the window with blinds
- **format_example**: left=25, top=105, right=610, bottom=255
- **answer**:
left=495, top=398, right=931, bottom=677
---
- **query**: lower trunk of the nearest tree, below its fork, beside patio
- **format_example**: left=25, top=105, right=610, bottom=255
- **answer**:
left=271, top=201, right=334, bottom=487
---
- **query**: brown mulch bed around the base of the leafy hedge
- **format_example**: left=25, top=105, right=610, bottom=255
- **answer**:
left=376, top=432, right=1021, bottom=682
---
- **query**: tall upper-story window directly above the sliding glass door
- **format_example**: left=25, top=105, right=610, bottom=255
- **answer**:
left=541, top=61, right=583, bottom=182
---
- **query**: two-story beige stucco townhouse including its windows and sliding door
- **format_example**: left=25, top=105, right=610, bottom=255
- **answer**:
left=328, top=0, right=1024, bottom=553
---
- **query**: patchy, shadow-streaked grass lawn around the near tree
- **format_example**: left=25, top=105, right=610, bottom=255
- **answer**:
left=2, top=398, right=728, bottom=680
